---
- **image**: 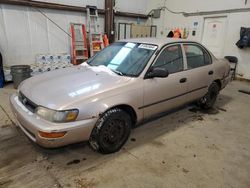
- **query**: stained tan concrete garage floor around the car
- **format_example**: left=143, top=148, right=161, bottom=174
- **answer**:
left=0, top=82, right=250, bottom=188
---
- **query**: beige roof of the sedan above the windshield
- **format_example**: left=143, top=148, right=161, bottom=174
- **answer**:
left=119, top=37, right=196, bottom=47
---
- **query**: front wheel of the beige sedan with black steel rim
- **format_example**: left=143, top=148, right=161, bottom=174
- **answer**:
left=89, top=108, right=132, bottom=154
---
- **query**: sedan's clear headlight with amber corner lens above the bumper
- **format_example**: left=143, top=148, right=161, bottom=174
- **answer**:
left=36, top=106, right=79, bottom=123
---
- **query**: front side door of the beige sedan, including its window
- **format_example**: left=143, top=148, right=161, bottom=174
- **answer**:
left=143, top=44, right=187, bottom=118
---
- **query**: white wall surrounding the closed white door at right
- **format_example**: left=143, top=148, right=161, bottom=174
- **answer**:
left=148, top=0, right=250, bottom=79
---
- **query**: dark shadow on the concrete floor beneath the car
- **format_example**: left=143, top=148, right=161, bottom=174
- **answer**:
left=0, top=95, right=232, bottom=176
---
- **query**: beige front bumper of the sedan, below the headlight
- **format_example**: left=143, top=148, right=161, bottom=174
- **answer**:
left=10, top=94, right=97, bottom=148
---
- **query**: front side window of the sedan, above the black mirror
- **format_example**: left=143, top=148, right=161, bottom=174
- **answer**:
left=153, top=45, right=183, bottom=74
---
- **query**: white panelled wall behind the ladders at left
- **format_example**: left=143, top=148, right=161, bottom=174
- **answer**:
left=0, top=0, right=148, bottom=66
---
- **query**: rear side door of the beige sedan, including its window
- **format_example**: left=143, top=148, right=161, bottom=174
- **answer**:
left=183, top=43, right=214, bottom=102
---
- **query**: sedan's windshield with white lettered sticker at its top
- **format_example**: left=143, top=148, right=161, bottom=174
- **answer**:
left=88, top=42, right=157, bottom=77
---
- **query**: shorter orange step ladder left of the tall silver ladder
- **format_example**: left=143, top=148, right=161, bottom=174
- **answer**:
left=70, top=23, right=89, bottom=65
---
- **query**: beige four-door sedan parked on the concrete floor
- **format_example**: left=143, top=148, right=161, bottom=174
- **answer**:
left=10, top=38, right=230, bottom=153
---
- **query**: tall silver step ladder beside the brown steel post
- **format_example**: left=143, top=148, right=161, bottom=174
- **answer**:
left=86, top=6, right=104, bottom=57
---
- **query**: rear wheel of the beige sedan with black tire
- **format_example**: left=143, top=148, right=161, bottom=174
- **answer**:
left=198, top=82, right=220, bottom=109
